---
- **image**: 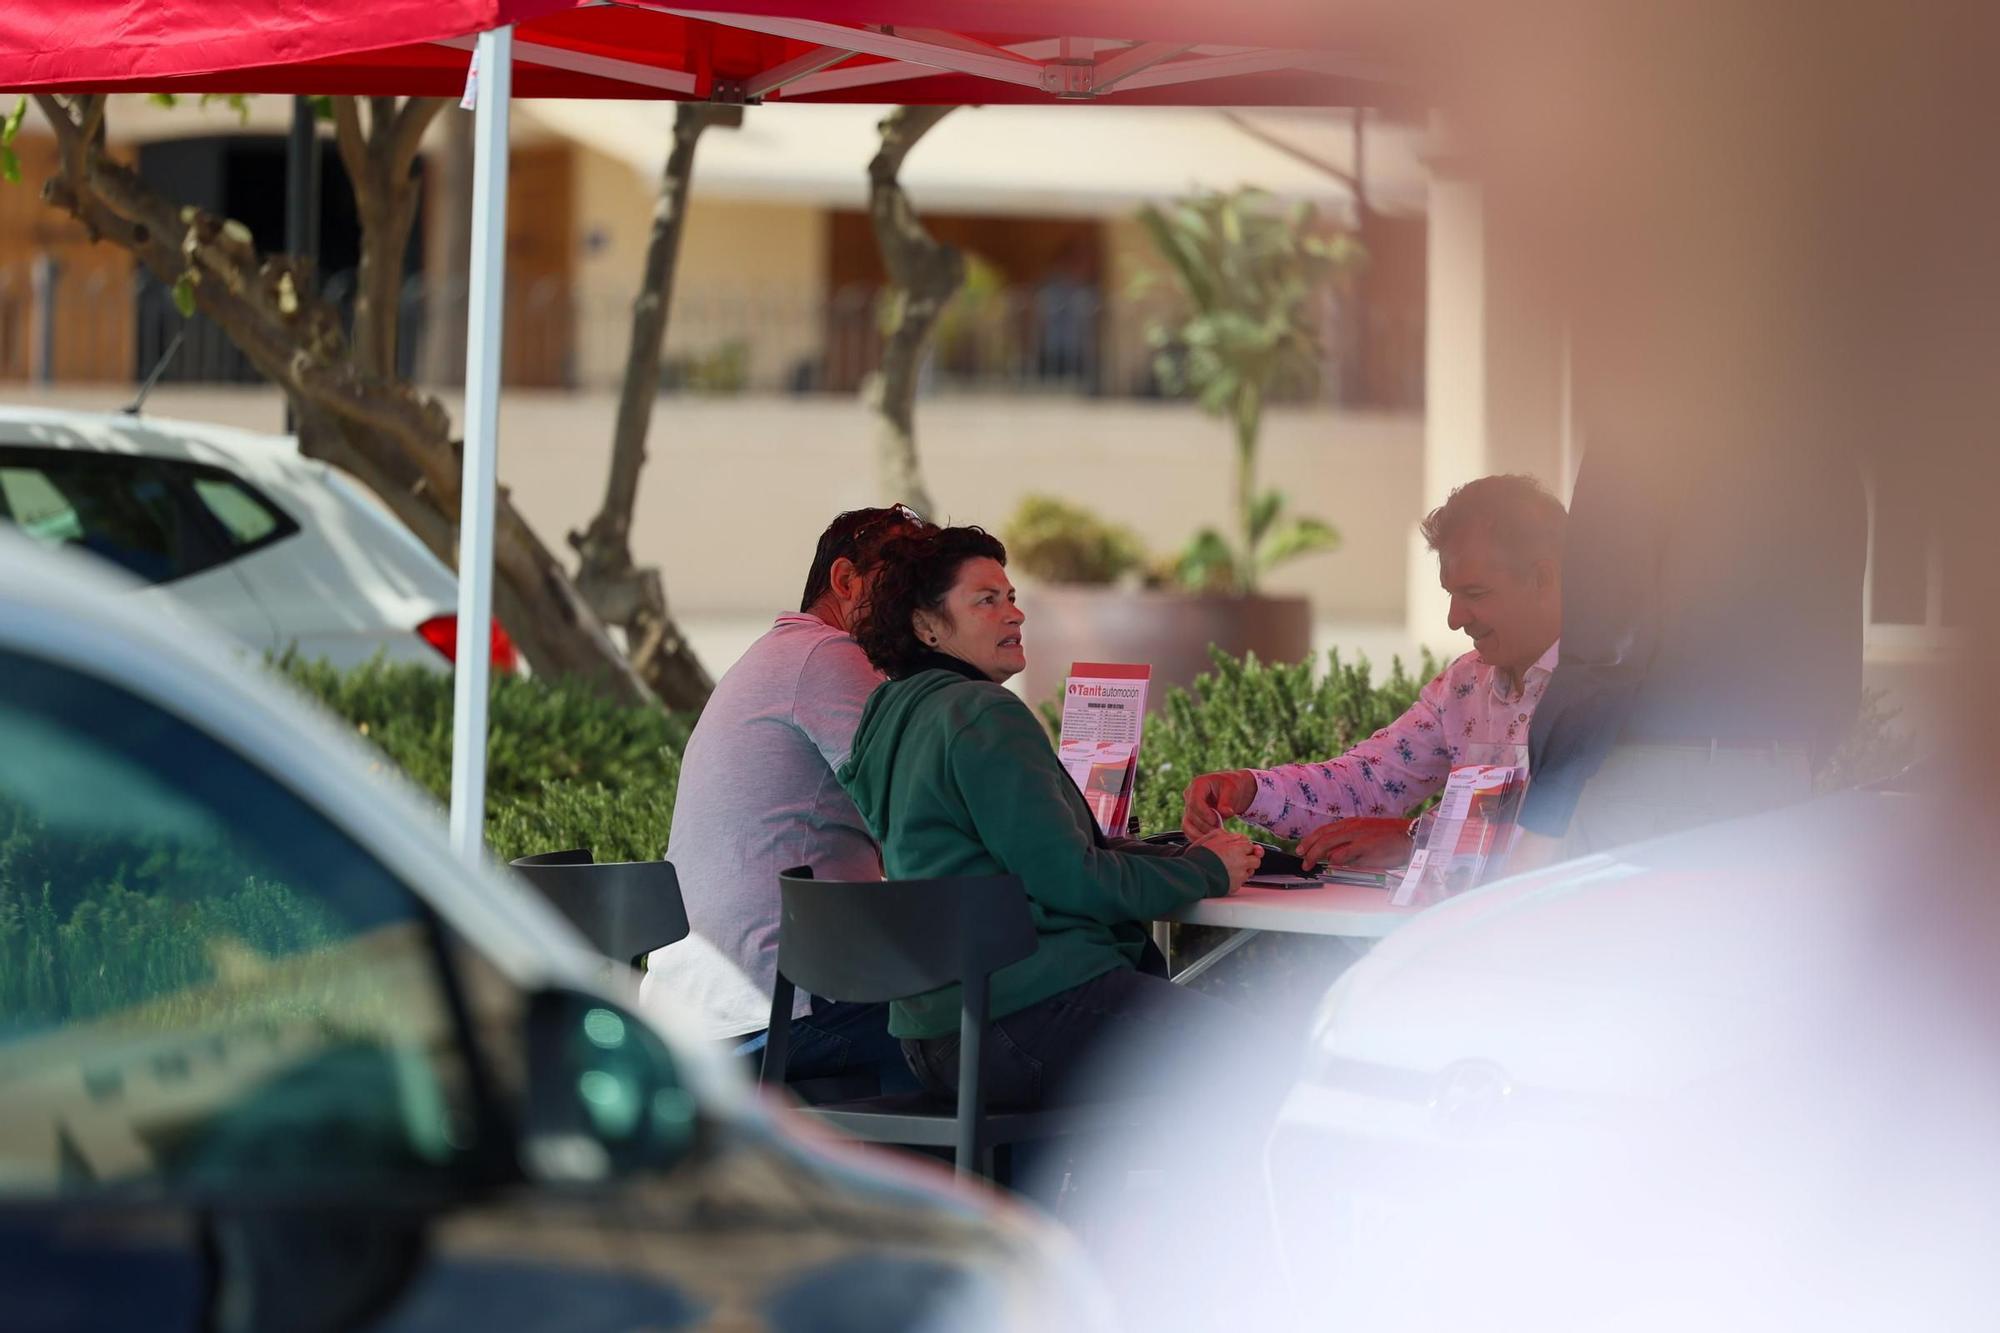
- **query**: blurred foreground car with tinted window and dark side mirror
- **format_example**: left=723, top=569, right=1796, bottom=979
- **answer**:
left=0, top=532, right=1102, bottom=1333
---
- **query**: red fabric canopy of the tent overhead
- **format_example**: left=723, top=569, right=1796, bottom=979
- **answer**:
left=0, top=0, right=1404, bottom=106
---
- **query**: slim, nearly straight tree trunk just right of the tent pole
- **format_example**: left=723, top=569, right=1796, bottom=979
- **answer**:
left=570, top=102, right=742, bottom=709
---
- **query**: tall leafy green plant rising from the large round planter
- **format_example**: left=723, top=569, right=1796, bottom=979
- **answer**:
left=1140, top=190, right=1364, bottom=596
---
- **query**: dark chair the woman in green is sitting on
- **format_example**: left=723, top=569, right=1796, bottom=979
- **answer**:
left=760, top=867, right=1136, bottom=1179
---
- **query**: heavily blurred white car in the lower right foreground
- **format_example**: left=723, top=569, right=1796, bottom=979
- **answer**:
left=1258, top=777, right=1976, bottom=1331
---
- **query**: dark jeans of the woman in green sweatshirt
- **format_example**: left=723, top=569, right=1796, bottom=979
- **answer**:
left=902, top=969, right=1242, bottom=1111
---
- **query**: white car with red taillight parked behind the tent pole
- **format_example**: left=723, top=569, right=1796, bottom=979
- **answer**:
left=0, top=406, right=516, bottom=671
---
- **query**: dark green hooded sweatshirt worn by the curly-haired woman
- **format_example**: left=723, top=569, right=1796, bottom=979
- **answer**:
left=836, top=669, right=1230, bottom=1037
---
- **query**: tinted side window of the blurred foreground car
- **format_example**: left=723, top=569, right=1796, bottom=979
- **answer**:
left=0, top=652, right=488, bottom=1205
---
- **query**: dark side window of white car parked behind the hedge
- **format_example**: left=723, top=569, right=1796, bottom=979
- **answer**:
left=0, top=450, right=216, bottom=582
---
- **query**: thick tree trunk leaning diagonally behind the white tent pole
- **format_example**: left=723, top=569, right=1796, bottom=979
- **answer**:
left=36, top=94, right=650, bottom=703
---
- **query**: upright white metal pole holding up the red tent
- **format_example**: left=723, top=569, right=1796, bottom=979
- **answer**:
left=452, top=28, right=514, bottom=865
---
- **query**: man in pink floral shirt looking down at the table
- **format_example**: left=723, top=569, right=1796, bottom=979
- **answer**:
left=1182, top=476, right=1566, bottom=867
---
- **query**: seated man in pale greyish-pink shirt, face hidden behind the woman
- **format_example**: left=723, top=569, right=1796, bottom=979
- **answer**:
left=642, top=504, right=924, bottom=1091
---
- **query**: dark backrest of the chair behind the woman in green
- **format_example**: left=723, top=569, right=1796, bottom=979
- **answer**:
left=778, top=867, right=1036, bottom=1005
